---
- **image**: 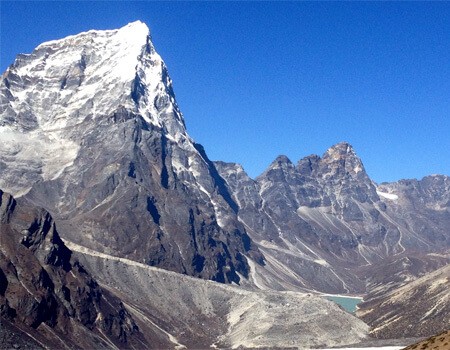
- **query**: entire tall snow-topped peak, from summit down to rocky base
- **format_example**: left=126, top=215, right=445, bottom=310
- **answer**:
left=0, top=22, right=262, bottom=283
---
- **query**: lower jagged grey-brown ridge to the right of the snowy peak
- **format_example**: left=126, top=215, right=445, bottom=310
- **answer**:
left=216, top=142, right=450, bottom=293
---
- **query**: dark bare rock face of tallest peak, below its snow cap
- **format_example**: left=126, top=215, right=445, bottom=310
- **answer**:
left=22, top=112, right=256, bottom=283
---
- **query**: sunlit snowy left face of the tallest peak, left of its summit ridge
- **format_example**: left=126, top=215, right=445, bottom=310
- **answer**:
left=7, top=21, right=155, bottom=131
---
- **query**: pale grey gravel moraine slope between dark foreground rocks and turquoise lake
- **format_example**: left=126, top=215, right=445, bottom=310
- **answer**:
left=68, top=244, right=368, bottom=348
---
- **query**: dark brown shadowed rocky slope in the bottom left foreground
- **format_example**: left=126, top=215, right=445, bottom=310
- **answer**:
left=0, top=191, right=151, bottom=348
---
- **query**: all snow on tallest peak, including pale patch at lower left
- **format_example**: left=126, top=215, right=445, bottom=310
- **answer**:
left=0, top=21, right=188, bottom=196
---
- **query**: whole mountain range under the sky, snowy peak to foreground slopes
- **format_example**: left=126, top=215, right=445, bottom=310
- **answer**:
left=0, top=21, right=450, bottom=348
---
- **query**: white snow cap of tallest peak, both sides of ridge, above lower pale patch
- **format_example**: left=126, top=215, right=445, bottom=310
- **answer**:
left=2, top=21, right=185, bottom=135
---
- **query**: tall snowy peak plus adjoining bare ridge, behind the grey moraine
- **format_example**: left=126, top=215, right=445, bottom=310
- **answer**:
left=0, top=22, right=450, bottom=344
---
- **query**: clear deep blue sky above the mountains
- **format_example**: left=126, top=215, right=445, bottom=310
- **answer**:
left=0, top=1, right=450, bottom=182
